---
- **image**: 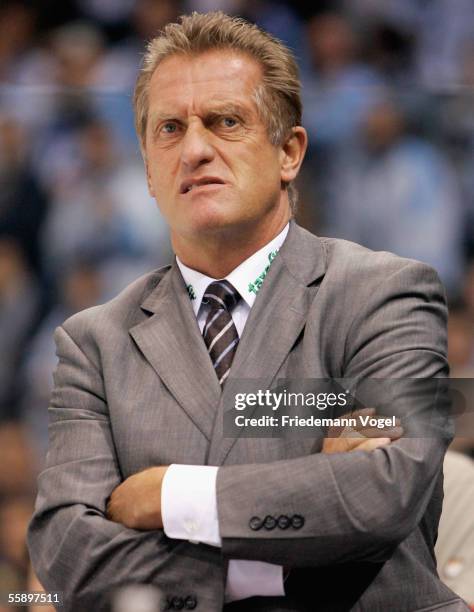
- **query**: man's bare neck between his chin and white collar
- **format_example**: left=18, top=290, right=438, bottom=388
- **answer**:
left=171, top=216, right=289, bottom=278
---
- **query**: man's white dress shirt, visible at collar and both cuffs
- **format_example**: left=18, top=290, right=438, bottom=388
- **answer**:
left=161, top=225, right=289, bottom=602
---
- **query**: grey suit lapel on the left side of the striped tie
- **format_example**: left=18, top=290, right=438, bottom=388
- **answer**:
left=130, top=262, right=221, bottom=439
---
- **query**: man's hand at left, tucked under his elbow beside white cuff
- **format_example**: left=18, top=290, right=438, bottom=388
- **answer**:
left=106, top=466, right=168, bottom=530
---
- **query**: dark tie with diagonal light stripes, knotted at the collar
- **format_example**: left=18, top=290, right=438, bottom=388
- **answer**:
left=202, top=280, right=240, bottom=385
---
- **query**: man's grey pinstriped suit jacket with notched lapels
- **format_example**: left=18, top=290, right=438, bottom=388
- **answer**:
left=28, top=222, right=466, bottom=612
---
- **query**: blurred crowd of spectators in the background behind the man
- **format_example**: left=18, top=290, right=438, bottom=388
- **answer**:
left=0, top=0, right=474, bottom=610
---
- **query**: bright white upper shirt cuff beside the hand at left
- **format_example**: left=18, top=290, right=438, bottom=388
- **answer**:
left=161, top=463, right=222, bottom=546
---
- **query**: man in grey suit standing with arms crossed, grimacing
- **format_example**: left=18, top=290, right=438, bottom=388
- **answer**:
left=29, top=13, right=465, bottom=612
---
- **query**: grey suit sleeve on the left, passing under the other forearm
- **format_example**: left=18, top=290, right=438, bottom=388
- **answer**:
left=28, top=327, right=224, bottom=612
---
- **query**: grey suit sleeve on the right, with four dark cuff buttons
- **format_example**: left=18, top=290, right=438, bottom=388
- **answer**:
left=217, top=262, right=449, bottom=567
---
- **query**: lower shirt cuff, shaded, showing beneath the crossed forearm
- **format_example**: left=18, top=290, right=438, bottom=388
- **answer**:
left=225, top=560, right=285, bottom=603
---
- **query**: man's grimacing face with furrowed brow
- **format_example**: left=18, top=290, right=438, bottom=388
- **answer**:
left=145, top=50, right=289, bottom=239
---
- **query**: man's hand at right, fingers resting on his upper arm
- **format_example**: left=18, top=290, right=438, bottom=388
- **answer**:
left=321, top=408, right=403, bottom=454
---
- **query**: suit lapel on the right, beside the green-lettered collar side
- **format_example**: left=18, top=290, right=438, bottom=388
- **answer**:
left=208, top=222, right=326, bottom=465
